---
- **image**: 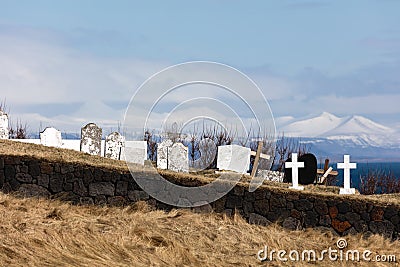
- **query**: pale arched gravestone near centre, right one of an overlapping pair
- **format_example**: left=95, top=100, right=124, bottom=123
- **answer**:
left=167, top=143, right=189, bottom=172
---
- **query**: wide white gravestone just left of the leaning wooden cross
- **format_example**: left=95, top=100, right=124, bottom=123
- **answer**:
left=217, top=145, right=251, bottom=173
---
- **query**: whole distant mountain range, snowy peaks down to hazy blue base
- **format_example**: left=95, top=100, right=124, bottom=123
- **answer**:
left=275, top=112, right=400, bottom=161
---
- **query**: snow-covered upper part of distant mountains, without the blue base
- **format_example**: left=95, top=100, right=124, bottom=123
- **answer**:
left=276, top=112, right=400, bottom=153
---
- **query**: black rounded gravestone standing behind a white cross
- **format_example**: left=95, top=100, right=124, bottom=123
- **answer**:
left=283, top=153, right=318, bottom=185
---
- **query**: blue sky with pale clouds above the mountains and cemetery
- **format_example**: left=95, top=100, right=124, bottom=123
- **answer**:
left=0, top=0, right=400, bottom=134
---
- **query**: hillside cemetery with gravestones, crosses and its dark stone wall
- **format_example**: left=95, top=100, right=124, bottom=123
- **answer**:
left=0, top=113, right=400, bottom=241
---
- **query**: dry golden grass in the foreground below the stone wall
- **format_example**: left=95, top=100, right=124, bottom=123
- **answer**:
left=0, top=193, right=400, bottom=266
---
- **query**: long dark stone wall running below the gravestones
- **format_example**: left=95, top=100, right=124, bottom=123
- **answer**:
left=0, top=156, right=400, bottom=241
